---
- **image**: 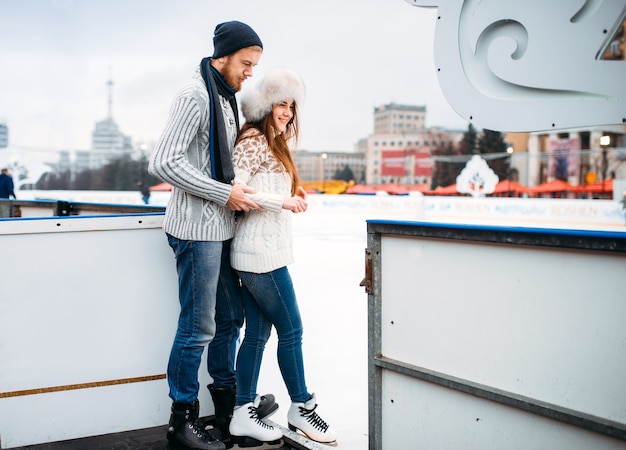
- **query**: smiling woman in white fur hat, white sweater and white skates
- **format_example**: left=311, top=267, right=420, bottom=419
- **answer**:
left=230, top=68, right=336, bottom=448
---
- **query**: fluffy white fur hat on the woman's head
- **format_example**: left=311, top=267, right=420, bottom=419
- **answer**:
left=241, top=67, right=305, bottom=122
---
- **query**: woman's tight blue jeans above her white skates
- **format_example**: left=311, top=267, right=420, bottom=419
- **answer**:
left=236, top=267, right=310, bottom=406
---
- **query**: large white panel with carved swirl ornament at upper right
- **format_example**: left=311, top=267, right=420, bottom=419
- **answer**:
left=406, top=0, right=626, bottom=131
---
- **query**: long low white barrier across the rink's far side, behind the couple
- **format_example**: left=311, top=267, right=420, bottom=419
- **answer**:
left=9, top=191, right=626, bottom=229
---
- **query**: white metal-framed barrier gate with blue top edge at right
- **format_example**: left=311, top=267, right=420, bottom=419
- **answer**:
left=364, top=220, right=626, bottom=450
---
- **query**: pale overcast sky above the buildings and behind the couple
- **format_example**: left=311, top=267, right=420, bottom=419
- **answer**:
left=0, top=0, right=467, bottom=161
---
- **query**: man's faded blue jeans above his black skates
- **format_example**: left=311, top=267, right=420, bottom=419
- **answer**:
left=167, top=235, right=243, bottom=403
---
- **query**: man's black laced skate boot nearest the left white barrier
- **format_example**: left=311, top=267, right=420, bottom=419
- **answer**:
left=167, top=400, right=226, bottom=450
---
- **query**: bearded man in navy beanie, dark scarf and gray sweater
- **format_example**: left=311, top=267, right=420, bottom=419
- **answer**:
left=148, top=21, right=278, bottom=450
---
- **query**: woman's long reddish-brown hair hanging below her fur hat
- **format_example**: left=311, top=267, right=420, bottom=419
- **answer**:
left=237, top=102, right=300, bottom=195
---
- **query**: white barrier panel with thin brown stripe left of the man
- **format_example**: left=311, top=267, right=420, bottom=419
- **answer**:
left=0, top=214, right=183, bottom=449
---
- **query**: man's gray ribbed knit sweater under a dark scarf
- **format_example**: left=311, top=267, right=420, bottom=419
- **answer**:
left=148, top=68, right=237, bottom=241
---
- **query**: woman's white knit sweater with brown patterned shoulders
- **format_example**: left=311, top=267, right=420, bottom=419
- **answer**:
left=231, top=130, right=294, bottom=273
